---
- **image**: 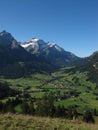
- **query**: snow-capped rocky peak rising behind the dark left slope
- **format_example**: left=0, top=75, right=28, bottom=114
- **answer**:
left=21, top=38, right=78, bottom=66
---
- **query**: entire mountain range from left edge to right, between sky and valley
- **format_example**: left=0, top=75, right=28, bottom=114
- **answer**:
left=0, top=31, right=98, bottom=81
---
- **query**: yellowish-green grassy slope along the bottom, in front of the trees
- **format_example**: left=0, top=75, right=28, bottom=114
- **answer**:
left=0, top=114, right=98, bottom=130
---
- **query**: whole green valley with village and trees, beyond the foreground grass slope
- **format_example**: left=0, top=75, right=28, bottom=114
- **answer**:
left=1, top=67, right=98, bottom=124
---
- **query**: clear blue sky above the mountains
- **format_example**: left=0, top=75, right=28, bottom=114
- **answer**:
left=0, top=0, right=98, bottom=57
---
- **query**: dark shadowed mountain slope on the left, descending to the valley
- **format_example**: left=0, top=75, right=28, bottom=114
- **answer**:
left=0, top=31, right=55, bottom=78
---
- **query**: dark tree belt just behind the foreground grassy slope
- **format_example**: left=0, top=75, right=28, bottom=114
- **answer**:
left=0, top=92, right=97, bottom=123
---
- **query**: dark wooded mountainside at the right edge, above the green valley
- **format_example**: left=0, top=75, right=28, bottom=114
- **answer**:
left=69, top=51, right=98, bottom=84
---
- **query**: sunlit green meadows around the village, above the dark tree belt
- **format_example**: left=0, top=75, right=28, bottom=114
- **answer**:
left=1, top=68, right=98, bottom=111
